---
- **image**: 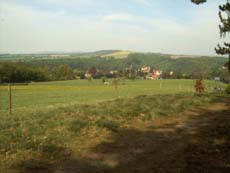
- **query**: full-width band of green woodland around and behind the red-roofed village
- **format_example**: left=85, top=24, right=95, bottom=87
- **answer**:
left=0, top=53, right=228, bottom=83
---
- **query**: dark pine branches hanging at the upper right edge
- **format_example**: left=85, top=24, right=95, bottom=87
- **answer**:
left=191, top=0, right=230, bottom=73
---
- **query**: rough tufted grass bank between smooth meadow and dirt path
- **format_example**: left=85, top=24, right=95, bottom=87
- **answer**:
left=0, top=94, right=223, bottom=169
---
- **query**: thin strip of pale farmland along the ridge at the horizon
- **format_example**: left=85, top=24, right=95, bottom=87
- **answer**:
left=0, top=50, right=224, bottom=62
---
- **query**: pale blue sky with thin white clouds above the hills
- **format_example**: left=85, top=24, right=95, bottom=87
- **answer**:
left=0, top=0, right=229, bottom=55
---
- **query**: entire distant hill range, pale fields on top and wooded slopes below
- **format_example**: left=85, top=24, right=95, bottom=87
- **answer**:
left=0, top=50, right=227, bottom=75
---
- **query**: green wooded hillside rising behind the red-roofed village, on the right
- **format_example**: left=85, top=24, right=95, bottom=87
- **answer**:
left=128, top=53, right=228, bottom=74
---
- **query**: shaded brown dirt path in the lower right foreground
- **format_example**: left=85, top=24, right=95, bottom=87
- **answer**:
left=55, top=100, right=230, bottom=173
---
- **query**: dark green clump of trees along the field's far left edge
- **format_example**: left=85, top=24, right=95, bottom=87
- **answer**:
left=0, top=62, right=74, bottom=83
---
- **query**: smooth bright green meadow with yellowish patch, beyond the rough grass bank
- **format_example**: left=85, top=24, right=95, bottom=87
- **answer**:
left=0, top=80, right=224, bottom=112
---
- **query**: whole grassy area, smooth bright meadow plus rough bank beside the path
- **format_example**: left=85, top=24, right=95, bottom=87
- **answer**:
left=0, top=80, right=225, bottom=172
